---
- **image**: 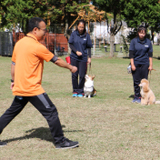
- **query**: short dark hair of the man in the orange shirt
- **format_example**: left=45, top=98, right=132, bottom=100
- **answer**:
left=28, top=17, right=45, bottom=32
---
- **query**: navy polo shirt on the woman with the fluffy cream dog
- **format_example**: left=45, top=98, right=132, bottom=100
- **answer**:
left=129, top=37, right=153, bottom=64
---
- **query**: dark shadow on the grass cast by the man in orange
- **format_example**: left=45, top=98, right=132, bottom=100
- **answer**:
left=4, top=125, right=84, bottom=143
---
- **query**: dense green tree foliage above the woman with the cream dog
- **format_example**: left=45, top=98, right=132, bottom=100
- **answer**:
left=121, top=0, right=160, bottom=43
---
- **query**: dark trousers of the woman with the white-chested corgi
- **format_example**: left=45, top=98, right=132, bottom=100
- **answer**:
left=71, top=58, right=87, bottom=94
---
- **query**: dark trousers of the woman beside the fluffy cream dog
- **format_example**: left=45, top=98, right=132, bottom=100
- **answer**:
left=132, top=64, right=149, bottom=98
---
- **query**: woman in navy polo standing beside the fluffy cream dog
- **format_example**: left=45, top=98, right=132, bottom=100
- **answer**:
left=129, top=26, right=153, bottom=103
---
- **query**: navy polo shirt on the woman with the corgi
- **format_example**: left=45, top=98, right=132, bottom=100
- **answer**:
left=68, top=30, right=92, bottom=62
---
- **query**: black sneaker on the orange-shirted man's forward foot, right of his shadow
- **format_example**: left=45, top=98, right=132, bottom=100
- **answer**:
left=55, top=138, right=79, bottom=149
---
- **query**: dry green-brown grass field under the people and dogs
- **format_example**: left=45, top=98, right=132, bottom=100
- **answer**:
left=0, top=46, right=160, bottom=160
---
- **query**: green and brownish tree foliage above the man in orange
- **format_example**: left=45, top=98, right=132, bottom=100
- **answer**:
left=0, top=0, right=88, bottom=32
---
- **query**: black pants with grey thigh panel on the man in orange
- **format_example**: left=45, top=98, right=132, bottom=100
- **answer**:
left=0, top=93, right=64, bottom=143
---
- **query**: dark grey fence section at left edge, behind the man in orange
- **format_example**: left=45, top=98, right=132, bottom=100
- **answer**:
left=0, top=32, right=13, bottom=56
